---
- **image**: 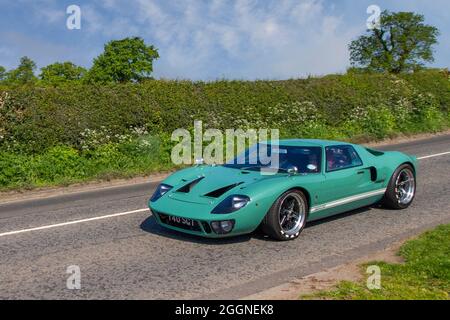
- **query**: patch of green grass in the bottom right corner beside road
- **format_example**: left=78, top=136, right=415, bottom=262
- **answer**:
left=300, top=225, right=450, bottom=300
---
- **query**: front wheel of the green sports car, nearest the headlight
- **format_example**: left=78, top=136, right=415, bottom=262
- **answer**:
left=261, top=190, right=308, bottom=241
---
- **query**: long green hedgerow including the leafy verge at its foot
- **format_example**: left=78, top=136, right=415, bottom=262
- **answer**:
left=0, top=70, right=450, bottom=187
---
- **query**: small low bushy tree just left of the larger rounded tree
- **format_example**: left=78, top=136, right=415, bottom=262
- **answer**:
left=40, top=62, right=86, bottom=85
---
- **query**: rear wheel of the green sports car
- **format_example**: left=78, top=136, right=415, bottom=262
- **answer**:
left=382, top=164, right=416, bottom=210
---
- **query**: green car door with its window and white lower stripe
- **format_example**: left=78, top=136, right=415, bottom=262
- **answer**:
left=311, top=145, right=374, bottom=217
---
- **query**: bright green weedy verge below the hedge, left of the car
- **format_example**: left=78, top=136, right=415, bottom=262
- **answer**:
left=0, top=136, right=177, bottom=192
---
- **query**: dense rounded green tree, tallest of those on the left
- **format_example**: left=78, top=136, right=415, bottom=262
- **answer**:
left=88, top=37, right=159, bottom=83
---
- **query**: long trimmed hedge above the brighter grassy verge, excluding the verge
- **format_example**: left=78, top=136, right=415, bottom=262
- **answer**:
left=0, top=71, right=450, bottom=153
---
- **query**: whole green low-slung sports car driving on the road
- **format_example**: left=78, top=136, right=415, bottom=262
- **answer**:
left=149, top=140, right=417, bottom=240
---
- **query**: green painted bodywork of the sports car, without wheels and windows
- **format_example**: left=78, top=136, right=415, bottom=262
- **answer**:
left=149, top=140, right=417, bottom=238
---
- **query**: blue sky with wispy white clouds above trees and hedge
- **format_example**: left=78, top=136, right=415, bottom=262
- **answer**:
left=0, top=0, right=450, bottom=81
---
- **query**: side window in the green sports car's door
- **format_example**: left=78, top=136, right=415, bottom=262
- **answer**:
left=325, top=145, right=363, bottom=172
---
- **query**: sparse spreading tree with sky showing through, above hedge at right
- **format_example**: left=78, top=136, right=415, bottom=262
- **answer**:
left=349, top=11, right=439, bottom=73
